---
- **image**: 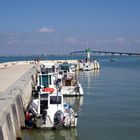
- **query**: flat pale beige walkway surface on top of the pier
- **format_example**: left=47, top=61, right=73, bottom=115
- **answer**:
left=0, top=64, right=33, bottom=92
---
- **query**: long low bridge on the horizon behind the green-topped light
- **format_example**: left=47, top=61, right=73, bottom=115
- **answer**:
left=70, top=51, right=140, bottom=56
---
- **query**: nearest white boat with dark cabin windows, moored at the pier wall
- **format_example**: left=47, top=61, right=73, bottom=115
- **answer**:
left=25, top=88, right=78, bottom=129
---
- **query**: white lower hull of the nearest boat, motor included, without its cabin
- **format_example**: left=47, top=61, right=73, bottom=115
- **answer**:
left=28, top=99, right=78, bottom=129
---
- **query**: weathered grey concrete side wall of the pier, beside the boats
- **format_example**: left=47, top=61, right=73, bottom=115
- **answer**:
left=0, top=66, right=36, bottom=140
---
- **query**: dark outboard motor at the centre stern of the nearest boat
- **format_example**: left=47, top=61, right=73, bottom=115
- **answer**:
left=54, top=110, right=64, bottom=129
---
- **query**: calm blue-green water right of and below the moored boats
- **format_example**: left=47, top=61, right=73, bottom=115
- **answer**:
left=2, top=56, right=140, bottom=140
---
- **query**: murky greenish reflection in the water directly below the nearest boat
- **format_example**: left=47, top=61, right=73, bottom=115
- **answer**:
left=22, top=128, right=78, bottom=140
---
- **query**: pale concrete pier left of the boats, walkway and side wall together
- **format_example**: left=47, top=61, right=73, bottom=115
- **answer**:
left=0, top=62, right=36, bottom=140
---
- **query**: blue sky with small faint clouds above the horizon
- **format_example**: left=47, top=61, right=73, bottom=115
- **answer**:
left=0, top=0, right=140, bottom=55
